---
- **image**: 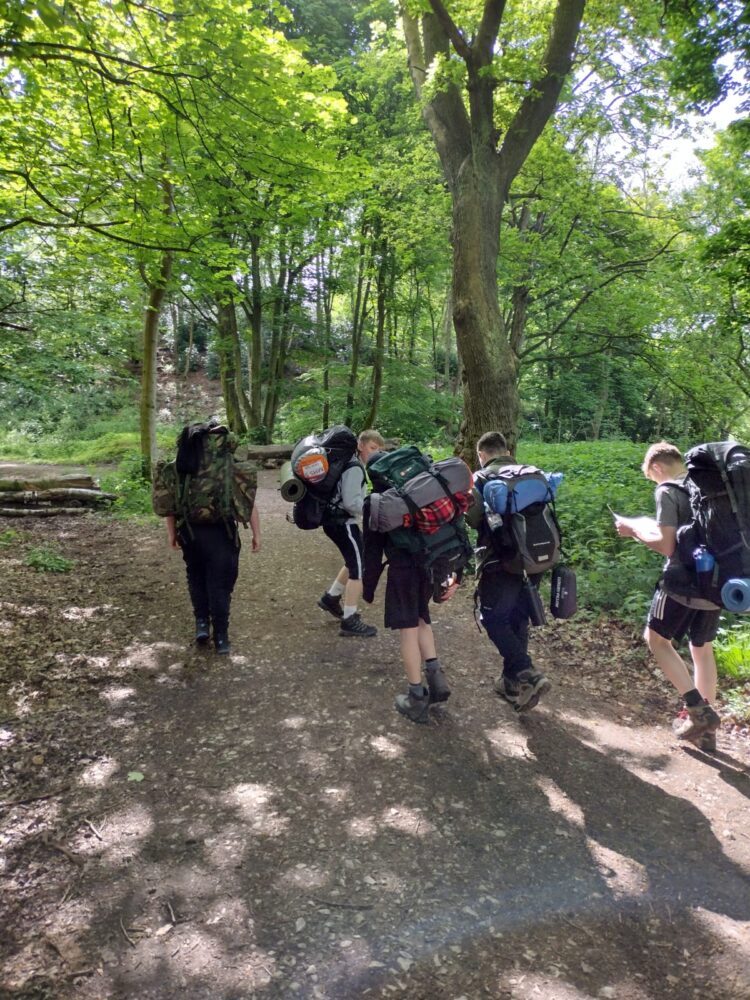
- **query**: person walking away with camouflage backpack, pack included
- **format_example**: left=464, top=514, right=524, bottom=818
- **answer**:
left=153, top=419, right=260, bottom=655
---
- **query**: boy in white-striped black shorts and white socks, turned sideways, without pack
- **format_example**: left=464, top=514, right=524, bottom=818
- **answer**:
left=318, top=430, right=385, bottom=638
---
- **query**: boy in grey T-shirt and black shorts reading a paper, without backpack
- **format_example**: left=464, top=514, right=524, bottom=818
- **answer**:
left=615, top=441, right=721, bottom=751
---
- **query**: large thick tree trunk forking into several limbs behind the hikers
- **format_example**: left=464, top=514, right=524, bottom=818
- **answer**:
left=401, top=0, right=585, bottom=461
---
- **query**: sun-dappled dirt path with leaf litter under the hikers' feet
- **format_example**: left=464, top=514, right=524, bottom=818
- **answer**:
left=0, top=473, right=750, bottom=1000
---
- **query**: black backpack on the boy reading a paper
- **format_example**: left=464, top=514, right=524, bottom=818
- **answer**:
left=665, top=441, right=750, bottom=604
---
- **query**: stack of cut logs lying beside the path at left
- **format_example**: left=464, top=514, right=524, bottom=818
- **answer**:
left=0, top=475, right=117, bottom=517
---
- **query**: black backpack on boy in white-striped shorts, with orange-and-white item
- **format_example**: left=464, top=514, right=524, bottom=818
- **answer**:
left=291, top=424, right=364, bottom=531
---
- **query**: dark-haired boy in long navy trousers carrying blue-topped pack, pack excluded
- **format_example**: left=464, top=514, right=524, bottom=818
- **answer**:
left=466, top=431, right=552, bottom=713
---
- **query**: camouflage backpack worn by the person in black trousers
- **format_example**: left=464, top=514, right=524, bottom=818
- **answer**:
left=152, top=425, right=257, bottom=527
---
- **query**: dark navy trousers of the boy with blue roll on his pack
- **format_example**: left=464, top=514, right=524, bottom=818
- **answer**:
left=479, top=570, right=533, bottom=679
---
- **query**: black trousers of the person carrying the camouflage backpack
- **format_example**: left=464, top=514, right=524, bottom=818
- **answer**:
left=179, top=523, right=240, bottom=633
